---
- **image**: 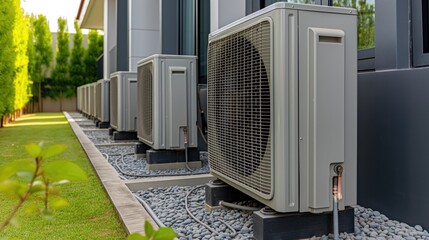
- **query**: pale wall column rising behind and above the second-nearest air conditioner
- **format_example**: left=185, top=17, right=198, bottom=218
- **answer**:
left=128, top=0, right=161, bottom=72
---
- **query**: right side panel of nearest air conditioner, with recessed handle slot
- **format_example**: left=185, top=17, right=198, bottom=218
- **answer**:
left=299, top=11, right=357, bottom=212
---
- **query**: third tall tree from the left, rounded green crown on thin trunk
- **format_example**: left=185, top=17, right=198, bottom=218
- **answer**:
left=32, top=14, right=53, bottom=112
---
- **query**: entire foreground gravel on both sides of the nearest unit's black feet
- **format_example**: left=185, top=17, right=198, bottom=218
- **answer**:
left=135, top=186, right=429, bottom=240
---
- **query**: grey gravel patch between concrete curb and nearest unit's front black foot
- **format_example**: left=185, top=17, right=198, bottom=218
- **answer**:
left=135, top=186, right=258, bottom=240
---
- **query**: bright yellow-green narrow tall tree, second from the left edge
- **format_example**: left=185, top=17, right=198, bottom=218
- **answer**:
left=13, top=3, right=30, bottom=114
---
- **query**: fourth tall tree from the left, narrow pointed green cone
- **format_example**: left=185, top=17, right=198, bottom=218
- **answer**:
left=50, top=17, right=73, bottom=111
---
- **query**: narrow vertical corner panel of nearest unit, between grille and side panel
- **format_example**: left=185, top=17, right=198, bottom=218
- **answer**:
left=271, top=10, right=299, bottom=212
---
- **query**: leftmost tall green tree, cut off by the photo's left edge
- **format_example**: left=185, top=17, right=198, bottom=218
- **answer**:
left=0, top=0, right=16, bottom=126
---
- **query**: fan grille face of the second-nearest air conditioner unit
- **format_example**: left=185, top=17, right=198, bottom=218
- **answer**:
left=137, top=62, right=153, bottom=143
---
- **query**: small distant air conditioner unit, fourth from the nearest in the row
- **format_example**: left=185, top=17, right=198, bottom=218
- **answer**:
left=95, top=79, right=110, bottom=122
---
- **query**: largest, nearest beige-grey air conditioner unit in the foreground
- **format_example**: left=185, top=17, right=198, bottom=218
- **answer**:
left=207, top=3, right=357, bottom=213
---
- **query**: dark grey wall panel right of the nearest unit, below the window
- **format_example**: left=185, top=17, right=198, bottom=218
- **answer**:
left=358, top=68, right=429, bottom=229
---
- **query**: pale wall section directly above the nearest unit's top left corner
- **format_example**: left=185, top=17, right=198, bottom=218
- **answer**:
left=210, top=0, right=246, bottom=32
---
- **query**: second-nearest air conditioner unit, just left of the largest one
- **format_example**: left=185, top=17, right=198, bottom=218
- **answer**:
left=137, top=55, right=198, bottom=150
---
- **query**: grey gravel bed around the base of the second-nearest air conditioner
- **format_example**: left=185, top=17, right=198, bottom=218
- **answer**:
left=98, top=146, right=210, bottom=179
